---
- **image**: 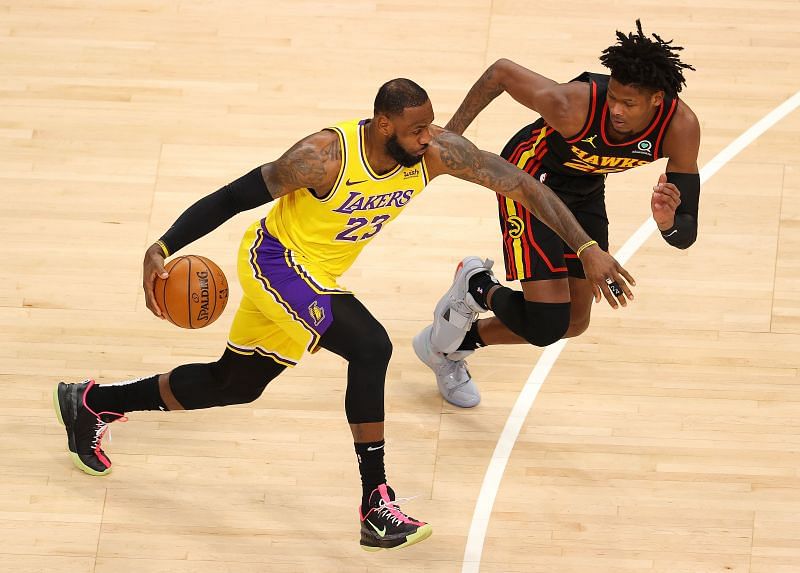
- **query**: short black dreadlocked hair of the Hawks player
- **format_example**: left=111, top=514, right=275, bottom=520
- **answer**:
left=600, top=19, right=694, bottom=97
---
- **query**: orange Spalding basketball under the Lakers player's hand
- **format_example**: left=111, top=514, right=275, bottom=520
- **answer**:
left=154, top=255, right=228, bottom=328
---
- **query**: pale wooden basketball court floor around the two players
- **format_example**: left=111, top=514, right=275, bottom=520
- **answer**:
left=0, top=0, right=800, bottom=573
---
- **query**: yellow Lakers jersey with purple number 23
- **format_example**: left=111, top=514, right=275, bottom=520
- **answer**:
left=266, top=120, right=428, bottom=278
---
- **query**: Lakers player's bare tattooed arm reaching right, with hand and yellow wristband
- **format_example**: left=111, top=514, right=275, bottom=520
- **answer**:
left=425, top=128, right=635, bottom=308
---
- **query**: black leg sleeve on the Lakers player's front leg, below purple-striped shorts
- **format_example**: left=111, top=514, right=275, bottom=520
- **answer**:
left=320, top=295, right=392, bottom=424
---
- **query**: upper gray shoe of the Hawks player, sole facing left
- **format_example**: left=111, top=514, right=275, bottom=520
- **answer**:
left=431, top=257, right=494, bottom=354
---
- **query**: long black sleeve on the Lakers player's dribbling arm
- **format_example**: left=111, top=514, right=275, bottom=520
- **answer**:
left=159, top=167, right=272, bottom=256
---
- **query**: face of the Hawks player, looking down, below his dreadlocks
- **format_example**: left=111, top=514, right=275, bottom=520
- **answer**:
left=606, top=78, right=664, bottom=137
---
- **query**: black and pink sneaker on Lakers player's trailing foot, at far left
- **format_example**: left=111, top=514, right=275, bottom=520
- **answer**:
left=53, top=380, right=126, bottom=476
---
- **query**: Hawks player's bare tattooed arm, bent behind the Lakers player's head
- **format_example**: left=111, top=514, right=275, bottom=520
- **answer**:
left=445, top=58, right=589, bottom=135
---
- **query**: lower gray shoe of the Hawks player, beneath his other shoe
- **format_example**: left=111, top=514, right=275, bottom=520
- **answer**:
left=413, top=325, right=481, bottom=408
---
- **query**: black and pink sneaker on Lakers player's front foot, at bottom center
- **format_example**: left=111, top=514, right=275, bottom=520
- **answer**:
left=359, top=483, right=433, bottom=551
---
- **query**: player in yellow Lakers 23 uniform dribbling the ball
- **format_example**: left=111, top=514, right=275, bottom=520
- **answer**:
left=54, top=79, right=632, bottom=551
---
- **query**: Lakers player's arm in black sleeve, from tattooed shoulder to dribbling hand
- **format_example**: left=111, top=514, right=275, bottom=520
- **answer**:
left=142, top=131, right=341, bottom=318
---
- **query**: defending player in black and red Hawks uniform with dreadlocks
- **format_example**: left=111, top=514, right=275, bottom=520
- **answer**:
left=414, top=20, right=700, bottom=407
